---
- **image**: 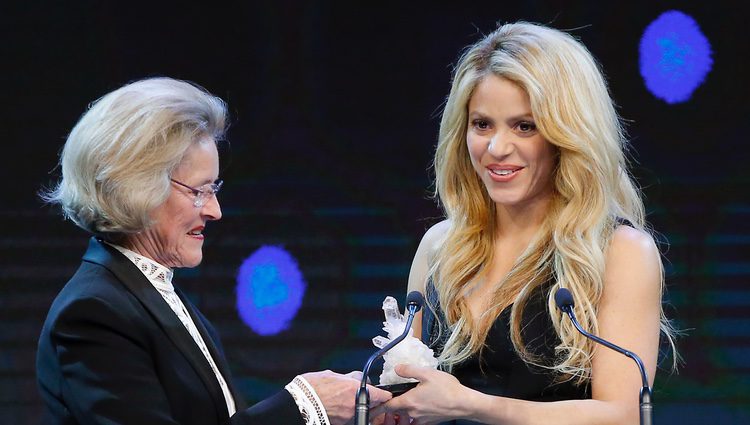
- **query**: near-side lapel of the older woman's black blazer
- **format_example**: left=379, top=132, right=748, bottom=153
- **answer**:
left=83, top=238, right=229, bottom=423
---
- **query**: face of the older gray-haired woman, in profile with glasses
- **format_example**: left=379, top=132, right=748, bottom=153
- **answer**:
left=125, top=138, right=221, bottom=267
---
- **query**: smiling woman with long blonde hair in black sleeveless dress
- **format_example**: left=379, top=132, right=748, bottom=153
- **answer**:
left=375, top=23, right=672, bottom=425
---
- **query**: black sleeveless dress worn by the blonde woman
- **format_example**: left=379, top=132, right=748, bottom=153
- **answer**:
left=422, top=281, right=591, bottom=425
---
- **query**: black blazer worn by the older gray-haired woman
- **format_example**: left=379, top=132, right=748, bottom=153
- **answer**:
left=36, top=238, right=303, bottom=425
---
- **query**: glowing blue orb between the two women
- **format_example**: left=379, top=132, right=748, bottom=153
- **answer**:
left=237, top=246, right=307, bottom=335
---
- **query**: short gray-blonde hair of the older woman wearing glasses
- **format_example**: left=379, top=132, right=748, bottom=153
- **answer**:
left=41, top=77, right=227, bottom=236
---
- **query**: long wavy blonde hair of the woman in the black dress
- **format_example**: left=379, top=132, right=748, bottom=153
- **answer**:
left=429, top=22, right=672, bottom=384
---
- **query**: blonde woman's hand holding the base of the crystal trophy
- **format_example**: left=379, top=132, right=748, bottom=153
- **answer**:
left=371, top=365, right=468, bottom=425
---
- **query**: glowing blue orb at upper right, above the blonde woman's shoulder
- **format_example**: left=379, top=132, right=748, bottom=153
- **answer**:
left=640, top=10, right=713, bottom=104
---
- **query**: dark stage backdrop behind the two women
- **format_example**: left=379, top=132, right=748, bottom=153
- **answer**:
left=0, top=0, right=750, bottom=424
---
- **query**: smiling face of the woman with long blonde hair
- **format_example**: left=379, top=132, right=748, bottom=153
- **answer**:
left=466, top=75, right=556, bottom=211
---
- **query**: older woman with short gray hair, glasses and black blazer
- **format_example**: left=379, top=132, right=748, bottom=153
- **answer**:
left=37, top=78, right=390, bottom=425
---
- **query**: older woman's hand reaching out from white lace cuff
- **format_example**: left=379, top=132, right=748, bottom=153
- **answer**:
left=302, top=370, right=392, bottom=425
